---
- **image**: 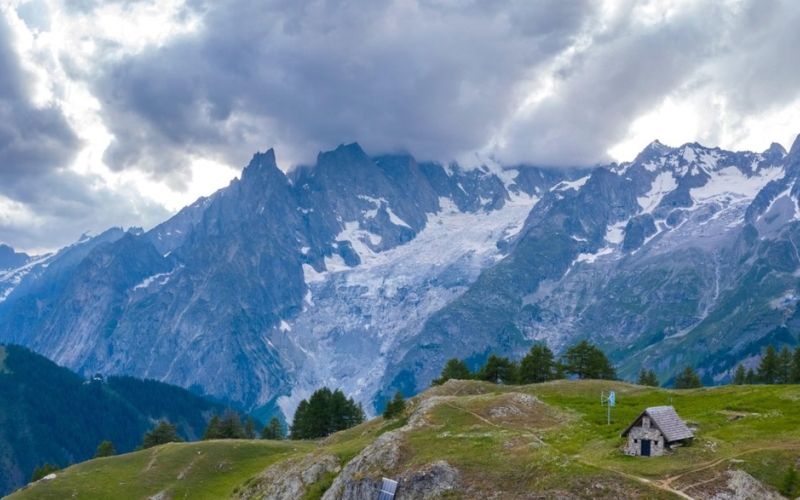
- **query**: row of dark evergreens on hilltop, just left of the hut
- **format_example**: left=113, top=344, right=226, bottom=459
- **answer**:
left=433, top=340, right=617, bottom=385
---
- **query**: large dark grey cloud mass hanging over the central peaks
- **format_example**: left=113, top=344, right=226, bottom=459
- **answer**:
left=96, top=0, right=594, bottom=182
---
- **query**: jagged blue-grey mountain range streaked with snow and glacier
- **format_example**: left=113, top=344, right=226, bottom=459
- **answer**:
left=0, top=140, right=800, bottom=417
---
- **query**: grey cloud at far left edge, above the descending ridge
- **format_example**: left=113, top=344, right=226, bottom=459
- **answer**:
left=0, top=15, right=166, bottom=249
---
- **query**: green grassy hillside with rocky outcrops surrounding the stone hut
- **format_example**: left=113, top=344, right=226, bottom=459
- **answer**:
left=11, top=381, right=800, bottom=499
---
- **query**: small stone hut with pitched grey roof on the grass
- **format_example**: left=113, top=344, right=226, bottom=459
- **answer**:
left=622, top=406, right=694, bottom=457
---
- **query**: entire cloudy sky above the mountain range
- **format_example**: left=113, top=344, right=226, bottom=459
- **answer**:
left=0, top=0, right=800, bottom=251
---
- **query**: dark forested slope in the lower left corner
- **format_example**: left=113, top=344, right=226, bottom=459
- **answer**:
left=0, top=345, right=242, bottom=494
